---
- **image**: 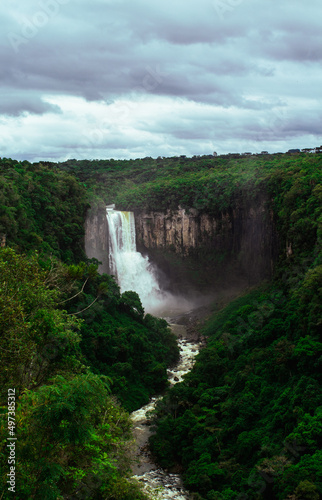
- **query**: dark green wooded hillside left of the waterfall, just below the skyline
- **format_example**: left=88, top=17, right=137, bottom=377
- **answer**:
left=0, top=158, right=89, bottom=263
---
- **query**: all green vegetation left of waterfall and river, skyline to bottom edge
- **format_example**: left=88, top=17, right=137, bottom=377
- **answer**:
left=0, top=159, right=178, bottom=500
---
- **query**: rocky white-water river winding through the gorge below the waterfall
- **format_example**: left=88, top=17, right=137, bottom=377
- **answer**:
left=131, top=325, right=201, bottom=500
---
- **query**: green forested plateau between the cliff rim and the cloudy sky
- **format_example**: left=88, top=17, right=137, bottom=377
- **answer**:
left=59, top=153, right=322, bottom=214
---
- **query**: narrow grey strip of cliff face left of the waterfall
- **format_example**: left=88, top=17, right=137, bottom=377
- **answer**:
left=85, top=210, right=109, bottom=273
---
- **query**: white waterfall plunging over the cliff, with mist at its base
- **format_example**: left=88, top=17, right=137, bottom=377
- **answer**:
left=106, top=207, right=195, bottom=317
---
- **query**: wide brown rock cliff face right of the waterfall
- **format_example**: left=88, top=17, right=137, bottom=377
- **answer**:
left=135, top=199, right=278, bottom=287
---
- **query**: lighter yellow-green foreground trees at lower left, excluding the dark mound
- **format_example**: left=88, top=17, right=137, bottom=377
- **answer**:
left=0, top=248, right=152, bottom=500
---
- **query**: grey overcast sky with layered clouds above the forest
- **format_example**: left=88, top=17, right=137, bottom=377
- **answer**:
left=0, top=0, right=322, bottom=162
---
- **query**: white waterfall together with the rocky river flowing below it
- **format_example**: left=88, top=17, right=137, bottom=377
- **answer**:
left=106, top=205, right=208, bottom=500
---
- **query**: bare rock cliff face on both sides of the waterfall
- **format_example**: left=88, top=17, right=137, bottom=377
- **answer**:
left=85, top=196, right=281, bottom=294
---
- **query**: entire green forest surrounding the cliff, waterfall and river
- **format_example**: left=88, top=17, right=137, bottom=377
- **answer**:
left=0, top=153, right=322, bottom=500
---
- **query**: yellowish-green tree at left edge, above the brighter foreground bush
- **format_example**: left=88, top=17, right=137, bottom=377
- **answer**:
left=0, top=248, right=80, bottom=391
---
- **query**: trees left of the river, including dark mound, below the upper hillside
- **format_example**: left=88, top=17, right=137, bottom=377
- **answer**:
left=0, top=248, right=178, bottom=500
